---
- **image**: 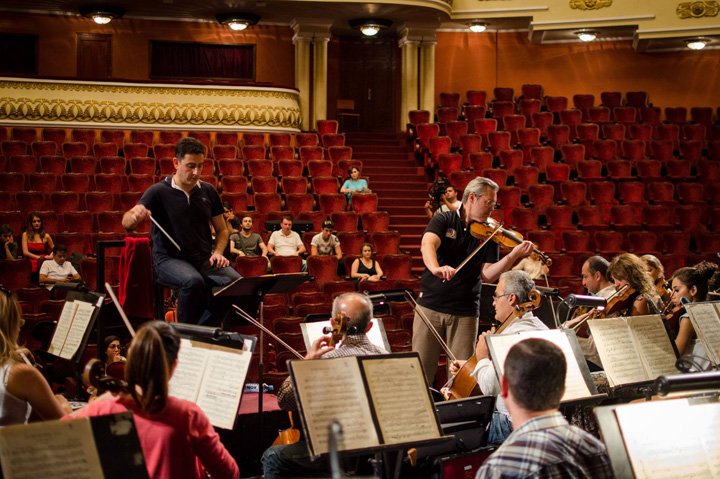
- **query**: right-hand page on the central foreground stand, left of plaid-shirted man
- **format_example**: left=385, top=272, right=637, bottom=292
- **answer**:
left=360, top=357, right=440, bottom=444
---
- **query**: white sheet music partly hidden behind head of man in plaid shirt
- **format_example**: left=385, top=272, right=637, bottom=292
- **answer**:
left=490, top=329, right=592, bottom=401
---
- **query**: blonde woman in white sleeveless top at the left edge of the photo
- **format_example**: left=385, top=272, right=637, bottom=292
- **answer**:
left=0, top=287, right=71, bottom=427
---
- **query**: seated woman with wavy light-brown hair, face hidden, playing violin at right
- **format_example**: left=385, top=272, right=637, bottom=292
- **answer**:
left=605, top=253, right=661, bottom=317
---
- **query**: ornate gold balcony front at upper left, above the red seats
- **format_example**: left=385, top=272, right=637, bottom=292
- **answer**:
left=0, top=80, right=302, bottom=131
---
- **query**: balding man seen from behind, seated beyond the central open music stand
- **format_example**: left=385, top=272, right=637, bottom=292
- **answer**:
left=262, top=293, right=387, bottom=479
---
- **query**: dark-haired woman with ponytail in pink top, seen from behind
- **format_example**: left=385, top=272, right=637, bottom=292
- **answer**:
left=70, top=321, right=240, bottom=479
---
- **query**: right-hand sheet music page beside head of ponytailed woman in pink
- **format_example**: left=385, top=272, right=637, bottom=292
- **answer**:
left=197, top=346, right=252, bottom=429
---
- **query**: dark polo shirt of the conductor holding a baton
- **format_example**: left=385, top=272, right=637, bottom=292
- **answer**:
left=138, top=176, right=223, bottom=264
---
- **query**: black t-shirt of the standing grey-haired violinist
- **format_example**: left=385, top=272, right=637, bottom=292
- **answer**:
left=418, top=209, right=500, bottom=316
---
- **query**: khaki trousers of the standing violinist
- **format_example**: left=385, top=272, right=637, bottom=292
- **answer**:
left=412, top=305, right=478, bottom=387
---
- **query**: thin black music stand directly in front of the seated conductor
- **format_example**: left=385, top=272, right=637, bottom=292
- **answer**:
left=213, top=273, right=311, bottom=447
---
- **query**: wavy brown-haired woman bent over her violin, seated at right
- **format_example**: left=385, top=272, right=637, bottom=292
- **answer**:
left=607, top=253, right=660, bottom=316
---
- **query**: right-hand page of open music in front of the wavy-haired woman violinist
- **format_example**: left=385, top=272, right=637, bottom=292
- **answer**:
left=626, top=314, right=677, bottom=379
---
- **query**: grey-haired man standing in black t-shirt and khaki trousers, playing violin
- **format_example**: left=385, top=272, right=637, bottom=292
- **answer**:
left=412, top=177, right=533, bottom=384
